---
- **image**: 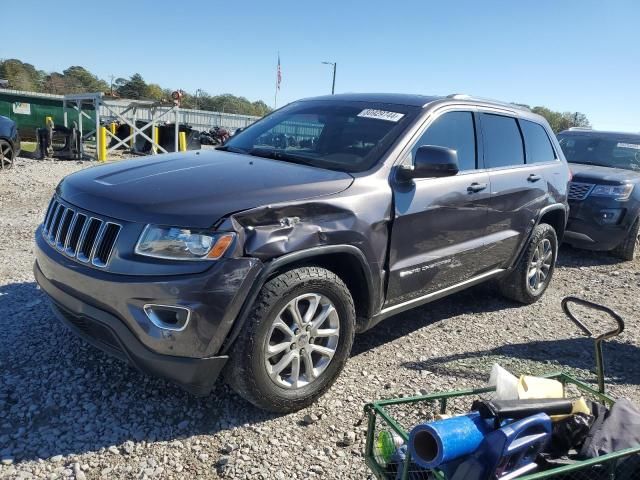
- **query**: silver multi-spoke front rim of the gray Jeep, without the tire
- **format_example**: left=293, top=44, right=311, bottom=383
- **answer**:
left=264, top=293, right=340, bottom=389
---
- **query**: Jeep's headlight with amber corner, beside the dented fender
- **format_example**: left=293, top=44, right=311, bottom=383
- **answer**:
left=135, top=225, right=235, bottom=260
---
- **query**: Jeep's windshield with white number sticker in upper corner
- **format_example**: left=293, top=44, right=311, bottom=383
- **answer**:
left=220, top=100, right=420, bottom=172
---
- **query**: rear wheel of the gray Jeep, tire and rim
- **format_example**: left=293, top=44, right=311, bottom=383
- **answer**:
left=498, top=223, right=558, bottom=305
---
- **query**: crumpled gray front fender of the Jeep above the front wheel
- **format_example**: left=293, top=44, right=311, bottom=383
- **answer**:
left=218, top=175, right=392, bottom=314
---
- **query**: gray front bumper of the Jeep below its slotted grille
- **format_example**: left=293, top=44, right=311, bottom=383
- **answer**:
left=34, top=229, right=261, bottom=394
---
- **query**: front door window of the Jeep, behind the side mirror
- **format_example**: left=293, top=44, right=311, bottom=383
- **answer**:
left=411, top=112, right=476, bottom=171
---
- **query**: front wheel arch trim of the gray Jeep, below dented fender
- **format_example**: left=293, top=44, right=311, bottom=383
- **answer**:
left=220, top=245, right=377, bottom=355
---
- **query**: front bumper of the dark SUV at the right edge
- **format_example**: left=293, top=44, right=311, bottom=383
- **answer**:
left=563, top=199, right=637, bottom=250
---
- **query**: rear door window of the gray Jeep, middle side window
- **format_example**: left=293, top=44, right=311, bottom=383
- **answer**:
left=480, top=113, right=524, bottom=168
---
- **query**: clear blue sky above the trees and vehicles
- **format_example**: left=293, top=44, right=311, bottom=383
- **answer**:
left=0, top=0, right=640, bottom=132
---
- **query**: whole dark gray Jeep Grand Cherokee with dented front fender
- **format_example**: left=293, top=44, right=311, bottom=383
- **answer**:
left=34, top=94, right=569, bottom=412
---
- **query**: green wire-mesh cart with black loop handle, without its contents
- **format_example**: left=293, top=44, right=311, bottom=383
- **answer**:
left=365, top=297, right=640, bottom=480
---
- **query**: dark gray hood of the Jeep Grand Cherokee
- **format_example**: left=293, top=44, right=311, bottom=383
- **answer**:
left=57, top=150, right=353, bottom=228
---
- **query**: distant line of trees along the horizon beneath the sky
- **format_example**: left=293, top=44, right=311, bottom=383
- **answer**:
left=0, top=59, right=590, bottom=133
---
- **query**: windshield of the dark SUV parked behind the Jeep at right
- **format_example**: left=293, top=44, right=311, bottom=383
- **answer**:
left=558, top=133, right=640, bottom=170
